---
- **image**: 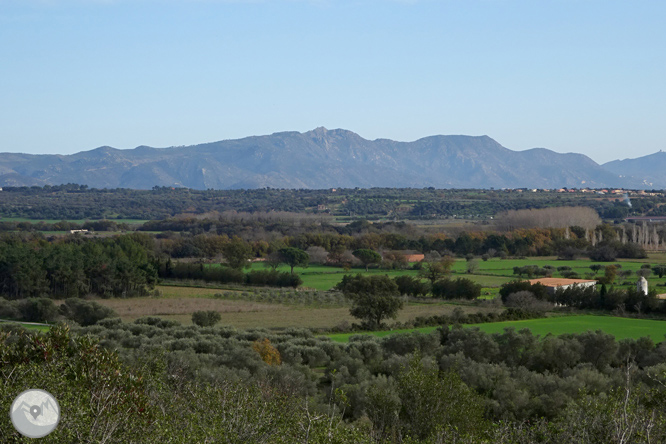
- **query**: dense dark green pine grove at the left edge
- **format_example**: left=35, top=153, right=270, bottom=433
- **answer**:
left=0, top=235, right=157, bottom=299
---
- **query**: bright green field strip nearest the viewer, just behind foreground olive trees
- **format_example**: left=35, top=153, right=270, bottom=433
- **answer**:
left=327, top=315, right=666, bottom=343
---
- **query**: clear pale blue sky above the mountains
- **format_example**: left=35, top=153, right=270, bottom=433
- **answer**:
left=0, top=0, right=666, bottom=163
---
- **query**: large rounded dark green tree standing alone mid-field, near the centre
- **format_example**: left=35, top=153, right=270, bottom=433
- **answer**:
left=336, top=274, right=403, bottom=330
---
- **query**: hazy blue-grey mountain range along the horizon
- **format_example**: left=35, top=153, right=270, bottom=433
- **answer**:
left=0, top=128, right=666, bottom=189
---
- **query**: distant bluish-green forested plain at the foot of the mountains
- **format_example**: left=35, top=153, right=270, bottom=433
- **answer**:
left=0, top=184, right=666, bottom=221
